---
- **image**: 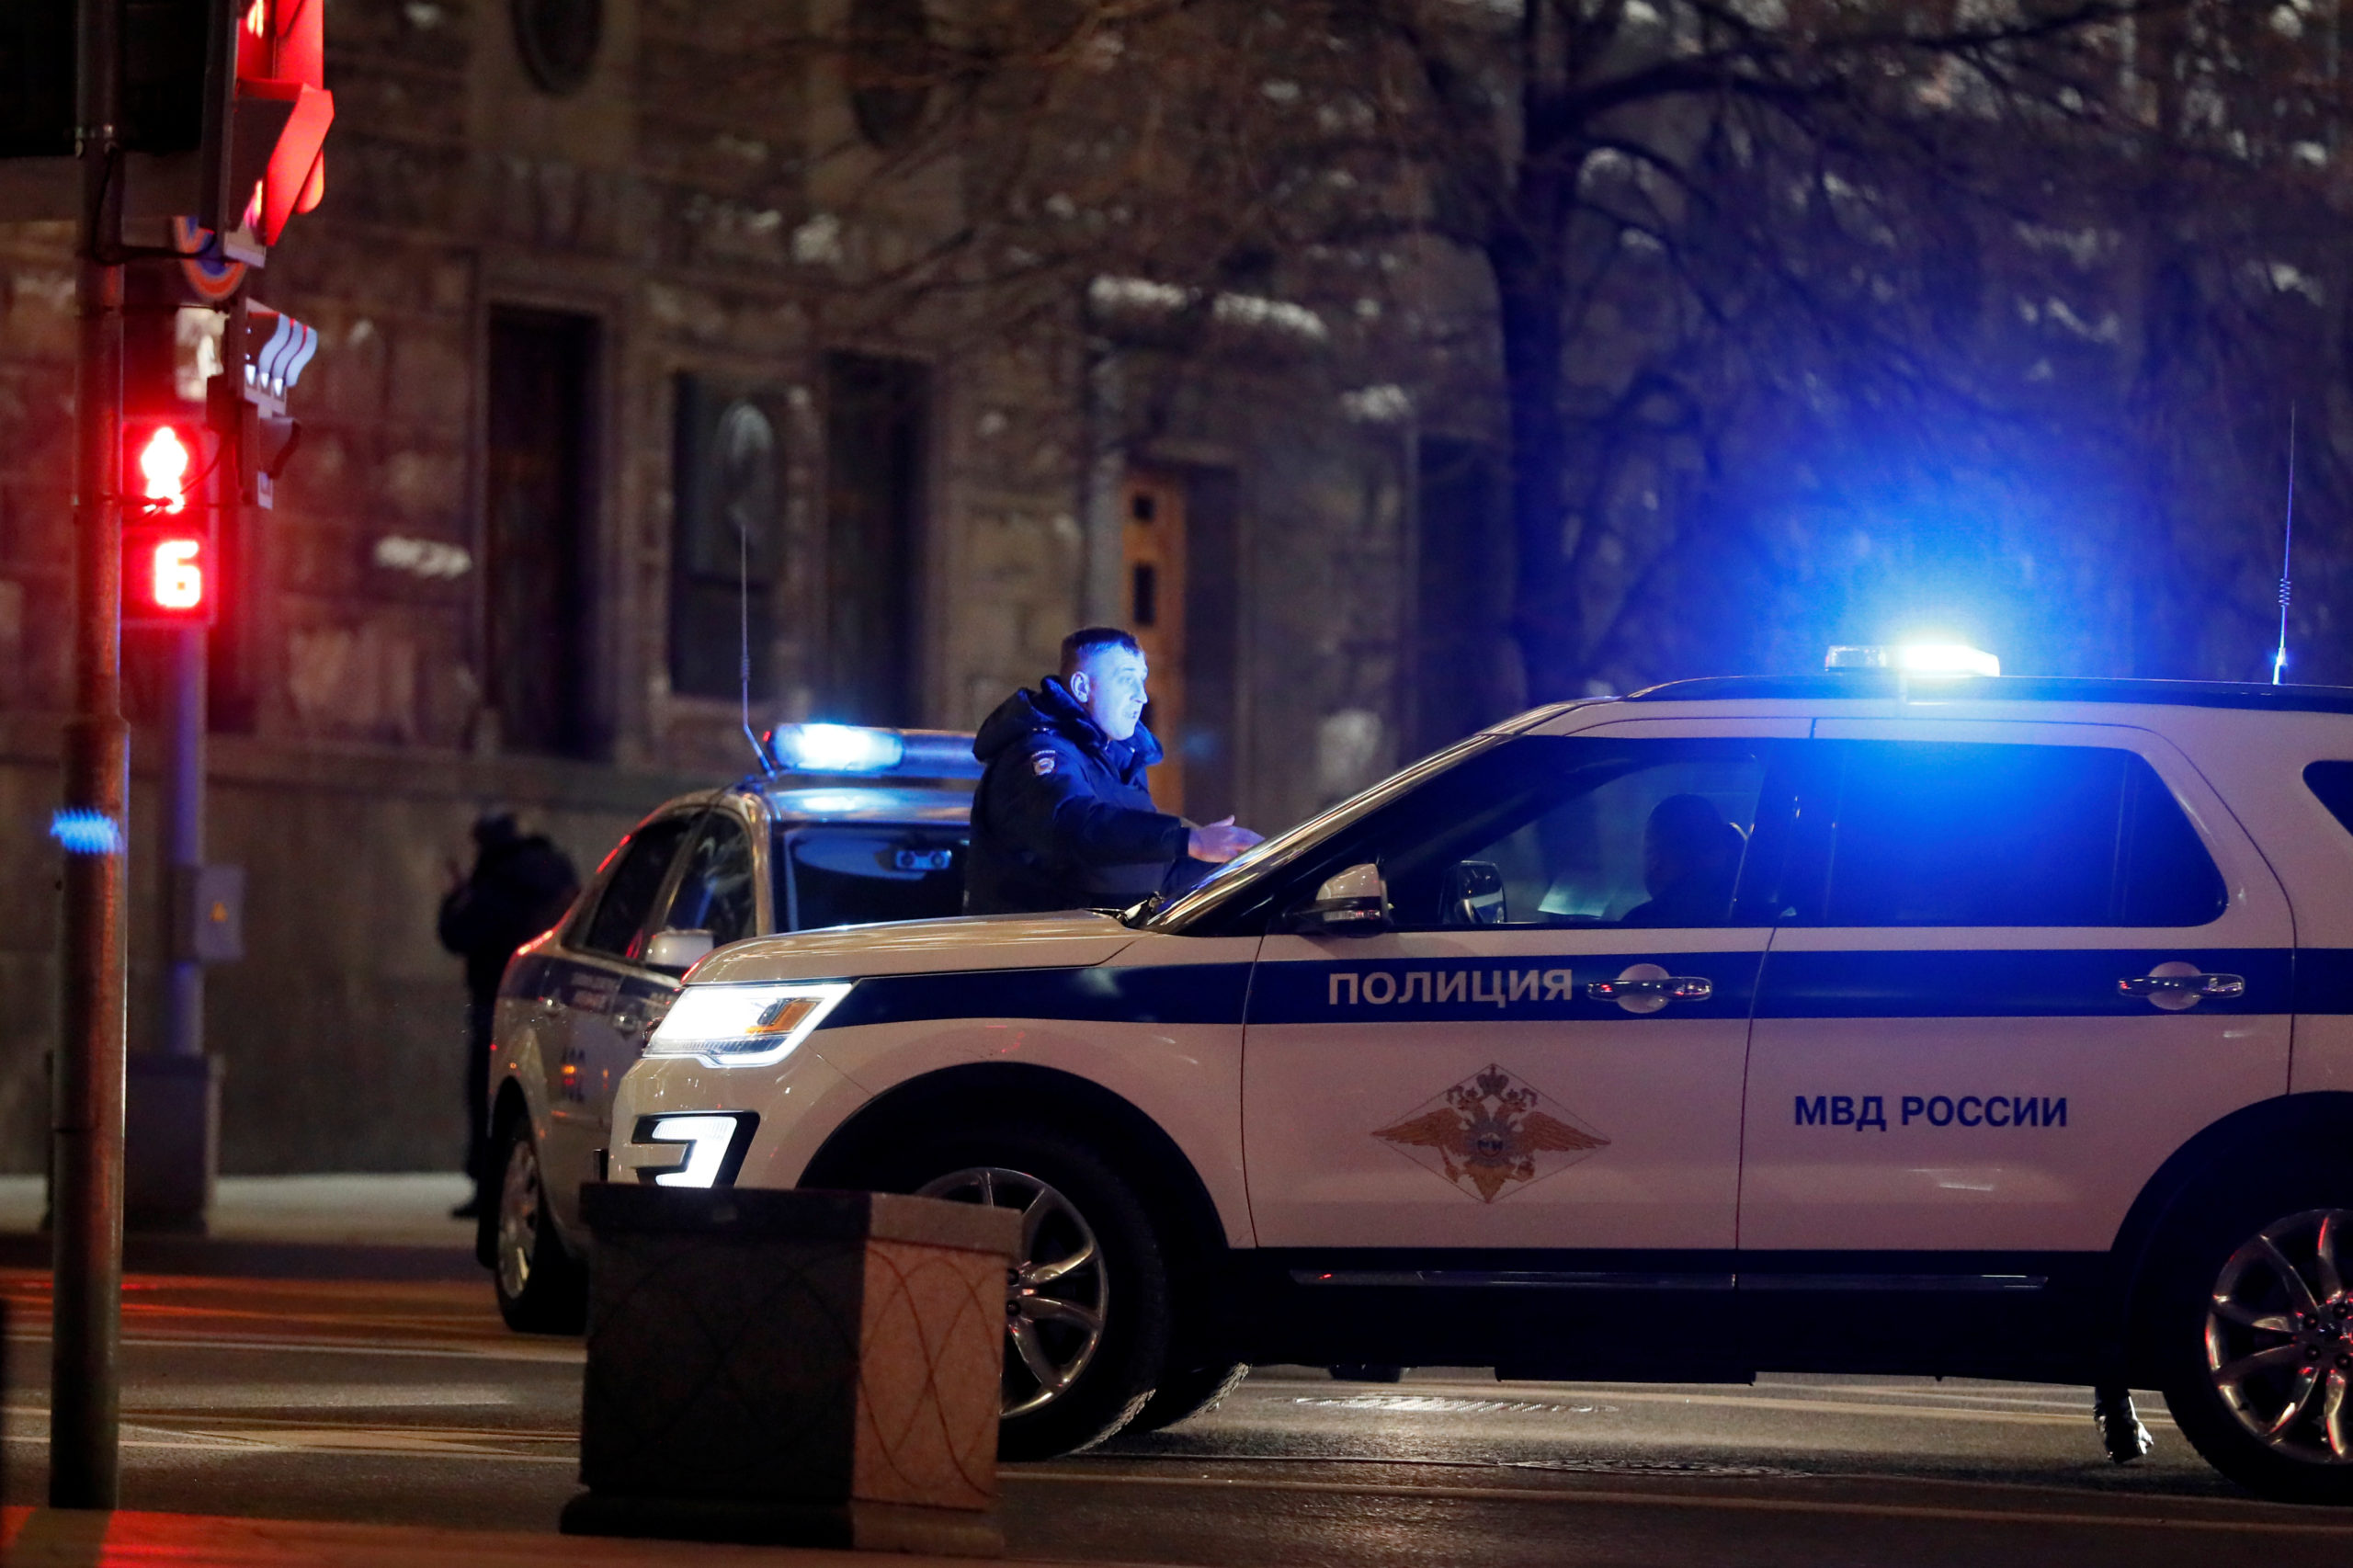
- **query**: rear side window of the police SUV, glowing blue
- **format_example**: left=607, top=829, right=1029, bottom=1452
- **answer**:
left=1816, top=742, right=2226, bottom=926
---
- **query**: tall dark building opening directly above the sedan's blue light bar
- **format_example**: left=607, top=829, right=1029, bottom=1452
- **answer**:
left=819, top=353, right=932, bottom=725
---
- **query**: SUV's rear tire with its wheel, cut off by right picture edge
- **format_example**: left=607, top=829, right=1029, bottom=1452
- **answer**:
left=2146, top=1170, right=2353, bottom=1505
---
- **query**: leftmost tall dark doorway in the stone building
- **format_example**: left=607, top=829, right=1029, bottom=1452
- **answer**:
left=483, top=311, right=597, bottom=756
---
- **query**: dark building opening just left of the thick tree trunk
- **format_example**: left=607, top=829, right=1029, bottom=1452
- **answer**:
left=1412, top=436, right=1513, bottom=756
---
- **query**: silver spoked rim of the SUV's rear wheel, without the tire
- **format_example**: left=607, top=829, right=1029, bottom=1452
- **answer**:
left=2205, top=1208, right=2353, bottom=1464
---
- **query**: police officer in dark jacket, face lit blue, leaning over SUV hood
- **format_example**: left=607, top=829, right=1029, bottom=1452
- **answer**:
left=965, top=626, right=1259, bottom=914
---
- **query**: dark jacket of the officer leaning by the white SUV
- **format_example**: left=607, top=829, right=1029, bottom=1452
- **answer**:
left=965, top=676, right=1186, bottom=914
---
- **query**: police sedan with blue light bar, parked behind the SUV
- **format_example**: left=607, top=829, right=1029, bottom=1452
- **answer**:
left=478, top=725, right=979, bottom=1330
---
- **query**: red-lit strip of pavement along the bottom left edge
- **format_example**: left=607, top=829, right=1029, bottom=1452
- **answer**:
left=0, top=1509, right=1110, bottom=1568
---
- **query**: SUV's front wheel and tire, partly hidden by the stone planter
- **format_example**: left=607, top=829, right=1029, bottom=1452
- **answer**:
left=869, top=1125, right=1172, bottom=1460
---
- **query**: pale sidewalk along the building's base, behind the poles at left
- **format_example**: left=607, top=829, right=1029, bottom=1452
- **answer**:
left=0, top=1173, right=480, bottom=1280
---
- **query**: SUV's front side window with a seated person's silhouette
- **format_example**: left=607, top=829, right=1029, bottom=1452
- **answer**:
left=1379, top=737, right=1765, bottom=930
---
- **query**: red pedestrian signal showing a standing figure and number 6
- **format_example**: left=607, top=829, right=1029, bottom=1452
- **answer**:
left=122, top=415, right=219, bottom=629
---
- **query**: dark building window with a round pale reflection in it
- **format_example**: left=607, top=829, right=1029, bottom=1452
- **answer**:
left=671, top=377, right=783, bottom=699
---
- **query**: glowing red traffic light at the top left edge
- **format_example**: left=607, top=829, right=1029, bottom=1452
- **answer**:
left=198, top=0, right=335, bottom=266
